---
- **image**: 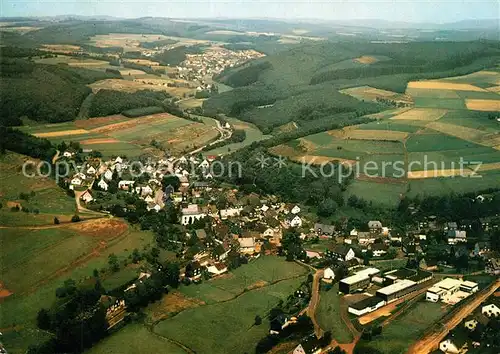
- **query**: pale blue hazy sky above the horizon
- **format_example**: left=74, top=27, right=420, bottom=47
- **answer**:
left=0, top=0, right=500, bottom=23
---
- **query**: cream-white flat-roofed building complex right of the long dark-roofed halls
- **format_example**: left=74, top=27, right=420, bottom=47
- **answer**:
left=425, top=278, right=478, bottom=304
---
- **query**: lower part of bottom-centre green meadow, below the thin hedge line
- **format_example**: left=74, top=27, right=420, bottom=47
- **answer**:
left=154, top=278, right=302, bottom=353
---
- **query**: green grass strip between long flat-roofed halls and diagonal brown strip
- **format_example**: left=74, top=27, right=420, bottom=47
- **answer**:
left=359, top=301, right=449, bottom=354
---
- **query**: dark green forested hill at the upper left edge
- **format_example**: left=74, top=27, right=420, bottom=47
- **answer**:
left=0, top=58, right=119, bottom=126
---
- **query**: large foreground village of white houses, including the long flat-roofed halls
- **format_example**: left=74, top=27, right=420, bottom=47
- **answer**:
left=51, top=147, right=500, bottom=354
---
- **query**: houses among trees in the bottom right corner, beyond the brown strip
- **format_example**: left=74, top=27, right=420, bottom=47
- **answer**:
left=436, top=292, right=500, bottom=354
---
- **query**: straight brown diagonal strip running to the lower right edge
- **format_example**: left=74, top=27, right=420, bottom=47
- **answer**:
left=408, top=280, right=500, bottom=354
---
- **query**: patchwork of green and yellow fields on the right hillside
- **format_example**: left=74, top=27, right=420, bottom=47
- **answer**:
left=270, top=71, right=500, bottom=205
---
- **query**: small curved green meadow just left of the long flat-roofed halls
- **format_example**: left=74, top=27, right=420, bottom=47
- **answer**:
left=316, top=283, right=353, bottom=343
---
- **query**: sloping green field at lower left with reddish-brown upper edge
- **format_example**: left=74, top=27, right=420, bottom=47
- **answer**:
left=0, top=224, right=153, bottom=353
